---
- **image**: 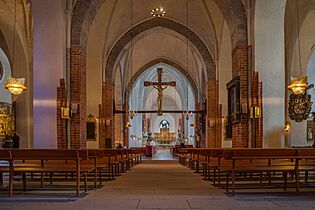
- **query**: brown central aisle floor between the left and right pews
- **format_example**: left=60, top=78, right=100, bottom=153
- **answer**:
left=104, top=160, right=217, bottom=196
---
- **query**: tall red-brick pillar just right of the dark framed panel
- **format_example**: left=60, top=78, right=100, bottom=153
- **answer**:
left=232, top=45, right=249, bottom=148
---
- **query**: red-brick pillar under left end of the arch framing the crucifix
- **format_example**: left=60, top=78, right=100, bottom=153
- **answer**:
left=102, top=80, right=115, bottom=146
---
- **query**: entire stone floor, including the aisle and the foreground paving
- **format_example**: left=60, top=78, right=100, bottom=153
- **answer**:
left=0, top=152, right=315, bottom=210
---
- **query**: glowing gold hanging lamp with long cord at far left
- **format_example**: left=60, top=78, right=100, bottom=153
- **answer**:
left=5, top=0, right=27, bottom=95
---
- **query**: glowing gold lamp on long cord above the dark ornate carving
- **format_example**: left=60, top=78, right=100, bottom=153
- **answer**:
left=288, top=0, right=308, bottom=94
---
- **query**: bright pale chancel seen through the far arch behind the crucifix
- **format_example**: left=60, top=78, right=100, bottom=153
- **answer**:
left=126, top=62, right=196, bottom=146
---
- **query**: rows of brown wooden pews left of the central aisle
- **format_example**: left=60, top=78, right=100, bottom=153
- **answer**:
left=0, top=148, right=143, bottom=196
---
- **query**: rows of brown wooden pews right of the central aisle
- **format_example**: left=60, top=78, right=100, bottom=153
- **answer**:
left=178, top=148, right=315, bottom=194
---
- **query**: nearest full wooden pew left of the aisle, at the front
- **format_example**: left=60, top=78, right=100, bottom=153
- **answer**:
left=9, top=149, right=95, bottom=196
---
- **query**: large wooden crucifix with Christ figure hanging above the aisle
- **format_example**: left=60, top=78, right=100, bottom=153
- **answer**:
left=144, top=68, right=176, bottom=116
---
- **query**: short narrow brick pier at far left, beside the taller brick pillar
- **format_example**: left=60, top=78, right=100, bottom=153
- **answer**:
left=57, top=79, right=67, bottom=149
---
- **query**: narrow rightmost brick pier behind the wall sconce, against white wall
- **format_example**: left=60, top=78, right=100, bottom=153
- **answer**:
left=251, top=72, right=263, bottom=148
